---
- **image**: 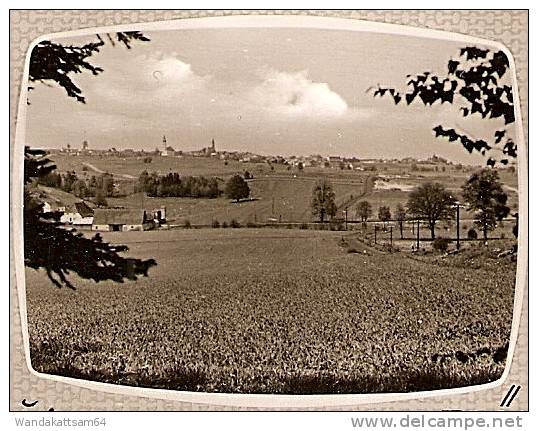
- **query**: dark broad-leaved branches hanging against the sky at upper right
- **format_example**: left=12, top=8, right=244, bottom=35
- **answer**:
left=373, top=47, right=517, bottom=166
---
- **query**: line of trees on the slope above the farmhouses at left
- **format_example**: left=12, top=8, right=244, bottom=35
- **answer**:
left=38, top=171, right=114, bottom=199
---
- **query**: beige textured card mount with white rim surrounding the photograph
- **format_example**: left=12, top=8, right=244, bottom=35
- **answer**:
left=9, top=10, right=528, bottom=411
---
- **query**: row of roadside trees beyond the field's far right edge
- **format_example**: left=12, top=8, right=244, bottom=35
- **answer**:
left=311, top=168, right=510, bottom=239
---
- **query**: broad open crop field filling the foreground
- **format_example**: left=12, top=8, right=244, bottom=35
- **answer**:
left=26, top=229, right=516, bottom=394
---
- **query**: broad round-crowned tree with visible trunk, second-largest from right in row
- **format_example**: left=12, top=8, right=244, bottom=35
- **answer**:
left=407, top=182, right=456, bottom=239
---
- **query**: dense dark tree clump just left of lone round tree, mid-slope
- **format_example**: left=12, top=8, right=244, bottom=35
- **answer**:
left=135, top=171, right=221, bottom=198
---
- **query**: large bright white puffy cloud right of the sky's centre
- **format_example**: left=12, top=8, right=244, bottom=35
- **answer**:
left=251, top=70, right=350, bottom=117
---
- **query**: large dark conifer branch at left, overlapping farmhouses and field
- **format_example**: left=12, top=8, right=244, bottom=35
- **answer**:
left=24, top=147, right=156, bottom=289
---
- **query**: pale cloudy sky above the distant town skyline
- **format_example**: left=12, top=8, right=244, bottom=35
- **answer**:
left=27, top=28, right=510, bottom=164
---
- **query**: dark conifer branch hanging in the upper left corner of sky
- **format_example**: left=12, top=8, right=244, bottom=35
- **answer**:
left=28, top=31, right=149, bottom=103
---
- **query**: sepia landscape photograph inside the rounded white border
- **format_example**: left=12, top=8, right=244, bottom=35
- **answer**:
left=21, top=16, right=525, bottom=402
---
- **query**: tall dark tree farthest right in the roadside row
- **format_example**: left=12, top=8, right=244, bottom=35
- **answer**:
left=462, top=168, right=510, bottom=239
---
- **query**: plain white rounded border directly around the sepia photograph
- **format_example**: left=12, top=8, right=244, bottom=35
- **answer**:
left=12, top=15, right=528, bottom=409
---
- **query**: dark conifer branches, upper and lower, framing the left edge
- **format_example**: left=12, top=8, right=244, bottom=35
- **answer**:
left=23, top=32, right=156, bottom=289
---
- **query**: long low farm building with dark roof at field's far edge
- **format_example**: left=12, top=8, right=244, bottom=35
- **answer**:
left=92, top=208, right=155, bottom=232
